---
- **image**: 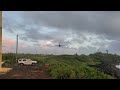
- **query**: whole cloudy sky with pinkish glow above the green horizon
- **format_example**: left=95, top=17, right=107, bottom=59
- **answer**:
left=2, top=11, right=120, bottom=54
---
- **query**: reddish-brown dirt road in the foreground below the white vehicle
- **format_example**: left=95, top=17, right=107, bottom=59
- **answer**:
left=0, top=66, right=51, bottom=79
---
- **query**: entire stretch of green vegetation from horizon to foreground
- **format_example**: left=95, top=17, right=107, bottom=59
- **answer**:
left=3, top=52, right=120, bottom=79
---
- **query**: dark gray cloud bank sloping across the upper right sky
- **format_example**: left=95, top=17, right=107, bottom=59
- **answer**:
left=20, top=11, right=120, bottom=38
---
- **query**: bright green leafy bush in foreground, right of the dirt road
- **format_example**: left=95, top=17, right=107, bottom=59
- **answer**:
left=49, top=62, right=113, bottom=79
